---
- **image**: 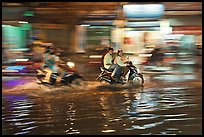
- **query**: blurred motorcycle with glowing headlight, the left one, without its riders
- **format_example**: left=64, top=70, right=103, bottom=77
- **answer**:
left=36, top=62, right=86, bottom=87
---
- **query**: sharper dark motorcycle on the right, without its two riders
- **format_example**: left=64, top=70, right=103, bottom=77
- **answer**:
left=96, top=61, right=144, bottom=85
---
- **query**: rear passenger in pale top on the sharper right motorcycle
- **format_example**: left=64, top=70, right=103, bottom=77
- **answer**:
left=103, top=47, right=122, bottom=82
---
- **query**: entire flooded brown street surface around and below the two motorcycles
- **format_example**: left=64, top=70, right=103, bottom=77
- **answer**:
left=2, top=54, right=202, bottom=135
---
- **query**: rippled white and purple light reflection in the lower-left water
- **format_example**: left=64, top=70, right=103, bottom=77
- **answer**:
left=2, top=95, right=37, bottom=135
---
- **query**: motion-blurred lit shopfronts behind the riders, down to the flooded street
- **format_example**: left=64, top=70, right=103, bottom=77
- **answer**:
left=2, top=2, right=202, bottom=77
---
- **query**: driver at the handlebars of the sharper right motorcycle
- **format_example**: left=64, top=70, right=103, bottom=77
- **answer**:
left=114, top=49, right=130, bottom=81
